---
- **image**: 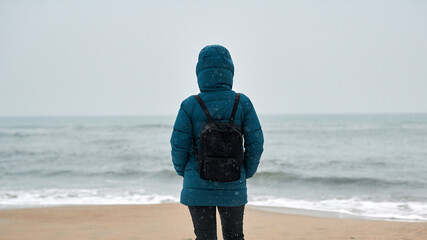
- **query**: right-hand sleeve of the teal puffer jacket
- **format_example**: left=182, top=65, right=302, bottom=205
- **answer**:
left=242, top=99, right=264, bottom=178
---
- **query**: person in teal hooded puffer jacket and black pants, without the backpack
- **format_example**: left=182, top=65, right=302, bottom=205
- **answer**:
left=170, top=45, right=264, bottom=240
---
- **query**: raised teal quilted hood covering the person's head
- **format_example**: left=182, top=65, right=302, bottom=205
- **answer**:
left=196, top=45, right=234, bottom=92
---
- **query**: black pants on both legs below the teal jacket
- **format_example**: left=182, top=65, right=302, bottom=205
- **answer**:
left=188, top=205, right=245, bottom=240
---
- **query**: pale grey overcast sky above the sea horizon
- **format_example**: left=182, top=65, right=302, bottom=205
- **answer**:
left=0, top=0, right=427, bottom=116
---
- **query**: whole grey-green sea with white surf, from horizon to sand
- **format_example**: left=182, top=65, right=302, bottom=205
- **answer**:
left=0, top=114, right=427, bottom=222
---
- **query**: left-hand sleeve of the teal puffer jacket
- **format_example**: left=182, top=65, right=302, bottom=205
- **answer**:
left=170, top=101, right=193, bottom=176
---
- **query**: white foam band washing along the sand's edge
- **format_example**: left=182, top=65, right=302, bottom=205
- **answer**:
left=0, top=189, right=427, bottom=221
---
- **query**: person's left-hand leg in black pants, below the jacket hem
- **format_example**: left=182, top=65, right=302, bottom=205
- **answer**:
left=188, top=206, right=217, bottom=240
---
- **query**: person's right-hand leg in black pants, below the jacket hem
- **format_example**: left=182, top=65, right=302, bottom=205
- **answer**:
left=218, top=205, right=245, bottom=240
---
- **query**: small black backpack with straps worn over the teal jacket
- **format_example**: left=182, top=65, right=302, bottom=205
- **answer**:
left=194, top=93, right=243, bottom=182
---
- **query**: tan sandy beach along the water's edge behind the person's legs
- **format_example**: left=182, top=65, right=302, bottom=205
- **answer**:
left=0, top=204, right=427, bottom=240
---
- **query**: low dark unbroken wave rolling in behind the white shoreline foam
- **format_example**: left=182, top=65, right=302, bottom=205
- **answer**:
left=0, top=165, right=427, bottom=188
